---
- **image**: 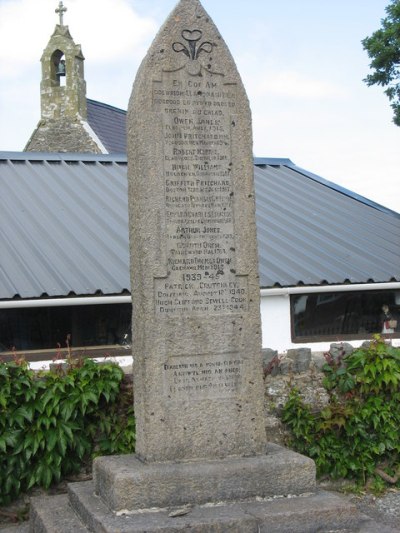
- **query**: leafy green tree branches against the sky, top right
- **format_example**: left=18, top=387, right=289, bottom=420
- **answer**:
left=361, top=0, right=400, bottom=126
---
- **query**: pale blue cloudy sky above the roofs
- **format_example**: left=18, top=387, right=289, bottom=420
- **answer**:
left=0, top=0, right=400, bottom=212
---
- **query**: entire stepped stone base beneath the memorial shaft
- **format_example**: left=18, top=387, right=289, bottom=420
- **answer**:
left=30, top=444, right=388, bottom=533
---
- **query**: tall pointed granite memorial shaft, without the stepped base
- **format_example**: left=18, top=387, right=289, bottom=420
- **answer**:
left=128, top=0, right=265, bottom=461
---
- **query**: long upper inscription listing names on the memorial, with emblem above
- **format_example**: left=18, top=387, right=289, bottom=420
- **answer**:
left=152, top=53, right=248, bottom=316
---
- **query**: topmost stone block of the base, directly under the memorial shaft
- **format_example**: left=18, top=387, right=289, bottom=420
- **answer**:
left=94, top=444, right=315, bottom=511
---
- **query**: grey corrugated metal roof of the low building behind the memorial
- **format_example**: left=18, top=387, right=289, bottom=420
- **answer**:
left=0, top=152, right=400, bottom=299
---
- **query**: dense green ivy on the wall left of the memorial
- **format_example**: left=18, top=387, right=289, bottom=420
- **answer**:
left=0, top=359, right=135, bottom=505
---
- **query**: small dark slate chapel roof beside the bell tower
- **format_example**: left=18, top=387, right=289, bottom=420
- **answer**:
left=86, top=98, right=126, bottom=154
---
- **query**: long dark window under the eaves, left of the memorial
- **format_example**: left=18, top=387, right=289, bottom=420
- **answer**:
left=0, top=304, right=132, bottom=354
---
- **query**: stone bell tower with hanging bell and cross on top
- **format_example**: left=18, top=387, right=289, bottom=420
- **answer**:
left=25, top=1, right=105, bottom=153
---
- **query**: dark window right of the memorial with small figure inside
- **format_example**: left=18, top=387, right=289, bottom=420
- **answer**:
left=290, top=290, right=400, bottom=342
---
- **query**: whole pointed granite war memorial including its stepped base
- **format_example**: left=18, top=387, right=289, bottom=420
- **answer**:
left=31, top=0, right=366, bottom=533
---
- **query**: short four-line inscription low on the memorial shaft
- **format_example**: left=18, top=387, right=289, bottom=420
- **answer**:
left=163, top=353, right=244, bottom=400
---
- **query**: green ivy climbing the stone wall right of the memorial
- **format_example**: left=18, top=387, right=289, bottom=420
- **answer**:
left=282, top=335, right=400, bottom=485
